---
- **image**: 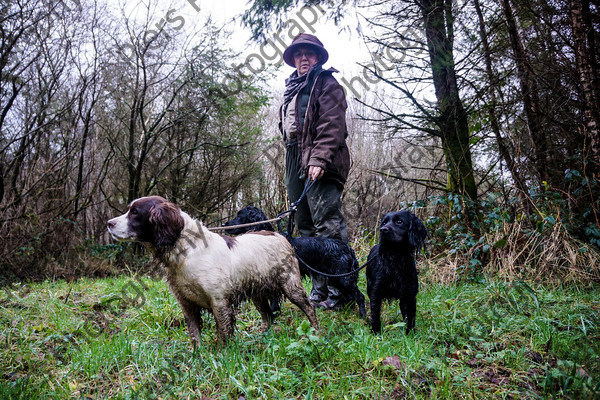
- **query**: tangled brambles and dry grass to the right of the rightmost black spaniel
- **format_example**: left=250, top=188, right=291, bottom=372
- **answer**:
left=404, top=170, right=600, bottom=282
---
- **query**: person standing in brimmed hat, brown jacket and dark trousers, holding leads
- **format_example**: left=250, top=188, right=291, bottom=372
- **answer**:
left=279, top=33, right=350, bottom=308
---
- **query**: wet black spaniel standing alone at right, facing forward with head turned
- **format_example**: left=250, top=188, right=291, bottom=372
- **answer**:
left=367, top=211, right=427, bottom=333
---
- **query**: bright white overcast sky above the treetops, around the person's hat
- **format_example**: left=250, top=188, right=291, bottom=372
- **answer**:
left=106, top=0, right=395, bottom=114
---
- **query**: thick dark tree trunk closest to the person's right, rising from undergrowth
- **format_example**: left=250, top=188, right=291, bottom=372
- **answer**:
left=420, top=0, right=477, bottom=199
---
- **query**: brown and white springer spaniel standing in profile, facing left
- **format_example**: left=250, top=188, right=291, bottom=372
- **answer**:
left=107, top=196, right=318, bottom=343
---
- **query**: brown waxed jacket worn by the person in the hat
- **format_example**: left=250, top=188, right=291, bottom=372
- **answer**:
left=279, top=68, right=350, bottom=185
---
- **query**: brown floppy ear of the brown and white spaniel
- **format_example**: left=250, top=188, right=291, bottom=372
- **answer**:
left=150, top=202, right=184, bottom=253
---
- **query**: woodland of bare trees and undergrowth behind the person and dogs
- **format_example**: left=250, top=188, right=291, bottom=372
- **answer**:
left=0, top=0, right=600, bottom=283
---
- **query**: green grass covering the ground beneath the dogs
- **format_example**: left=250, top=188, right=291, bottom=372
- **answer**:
left=0, top=274, right=600, bottom=399
